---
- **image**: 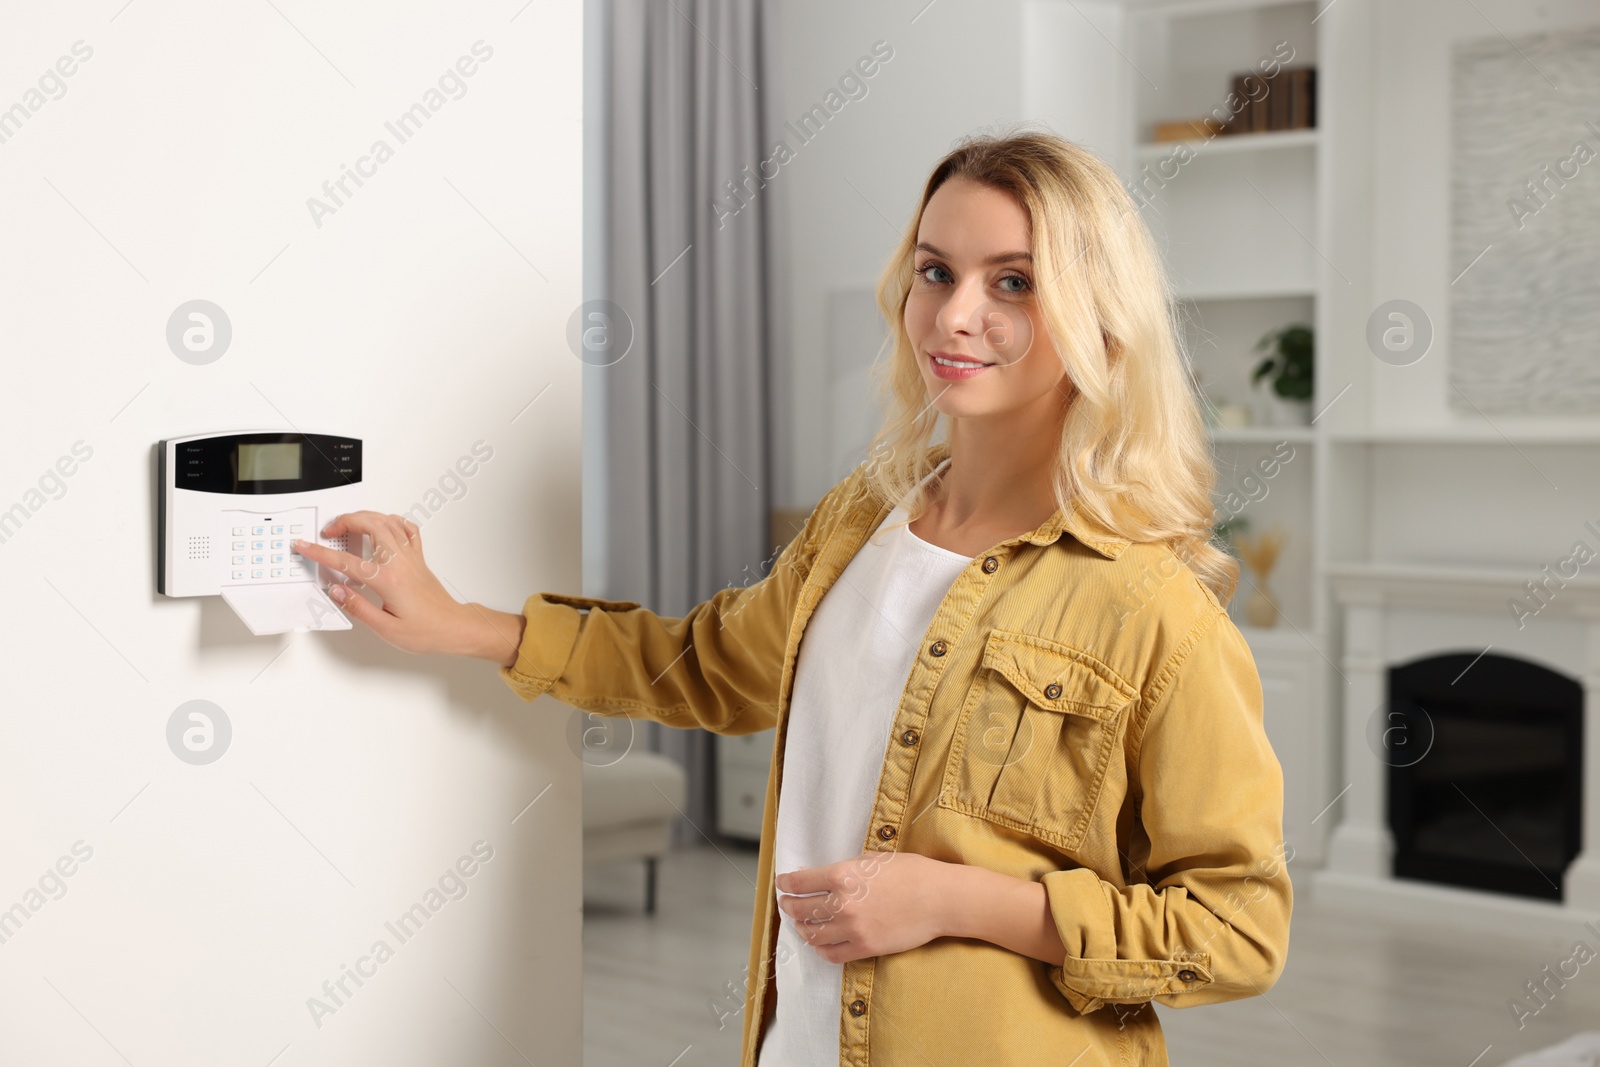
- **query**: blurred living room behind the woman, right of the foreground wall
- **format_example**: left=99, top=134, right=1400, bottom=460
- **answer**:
left=584, top=0, right=1600, bottom=1067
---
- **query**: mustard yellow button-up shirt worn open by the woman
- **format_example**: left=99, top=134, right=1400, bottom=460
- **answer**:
left=499, top=443, right=1293, bottom=1067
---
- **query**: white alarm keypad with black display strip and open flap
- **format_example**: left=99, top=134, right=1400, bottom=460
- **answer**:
left=157, top=430, right=362, bottom=635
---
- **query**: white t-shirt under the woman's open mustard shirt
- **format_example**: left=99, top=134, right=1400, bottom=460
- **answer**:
left=758, top=459, right=971, bottom=1067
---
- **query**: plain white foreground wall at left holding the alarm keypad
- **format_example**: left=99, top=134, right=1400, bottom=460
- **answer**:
left=0, top=0, right=582, bottom=1067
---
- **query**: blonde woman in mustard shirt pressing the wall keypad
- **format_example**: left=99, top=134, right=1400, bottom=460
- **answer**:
left=302, top=134, right=1293, bottom=1067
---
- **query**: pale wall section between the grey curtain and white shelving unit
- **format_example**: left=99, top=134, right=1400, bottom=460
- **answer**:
left=774, top=0, right=1022, bottom=507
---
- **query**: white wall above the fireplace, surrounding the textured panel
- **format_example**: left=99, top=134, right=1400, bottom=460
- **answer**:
left=1331, top=0, right=1600, bottom=579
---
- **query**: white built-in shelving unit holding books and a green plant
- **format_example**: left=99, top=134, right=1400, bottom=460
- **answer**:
left=1117, top=0, right=1349, bottom=865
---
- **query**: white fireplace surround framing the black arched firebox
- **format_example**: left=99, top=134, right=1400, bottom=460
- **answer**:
left=1314, top=560, right=1600, bottom=929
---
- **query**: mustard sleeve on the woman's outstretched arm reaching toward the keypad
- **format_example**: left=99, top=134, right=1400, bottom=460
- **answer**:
left=499, top=480, right=848, bottom=734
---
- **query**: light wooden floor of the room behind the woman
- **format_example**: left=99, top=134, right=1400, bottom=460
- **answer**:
left=584, top=845, right=1600, bottom=1067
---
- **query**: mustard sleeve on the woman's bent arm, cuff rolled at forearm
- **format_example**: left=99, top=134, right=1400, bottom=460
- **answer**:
left=1042, top=611, right=1293, bottom=1013
